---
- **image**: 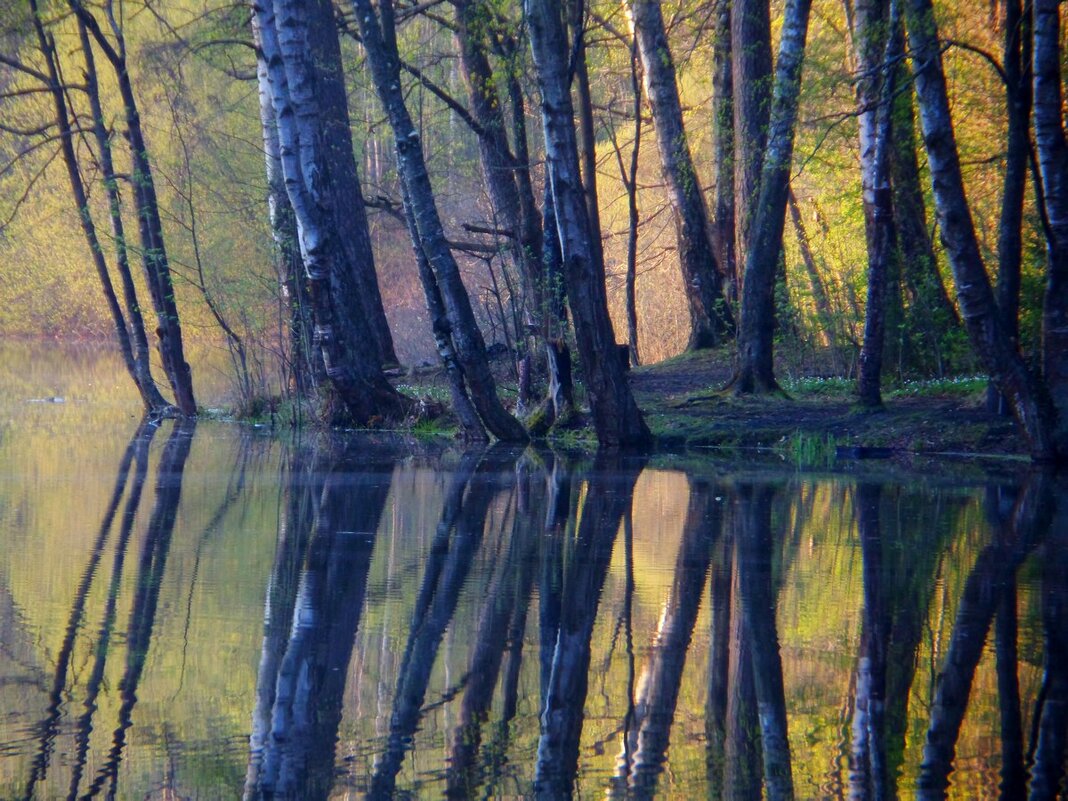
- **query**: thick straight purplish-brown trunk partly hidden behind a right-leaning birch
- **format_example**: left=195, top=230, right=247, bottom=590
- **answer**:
left=731, top=0, right=772, bottom=271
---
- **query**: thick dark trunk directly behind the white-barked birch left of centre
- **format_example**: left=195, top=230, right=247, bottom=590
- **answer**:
left=305, top=0, right=398, bottom=364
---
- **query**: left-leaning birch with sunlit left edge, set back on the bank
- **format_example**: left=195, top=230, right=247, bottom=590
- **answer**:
left=631, top=0, right=734, bottom=350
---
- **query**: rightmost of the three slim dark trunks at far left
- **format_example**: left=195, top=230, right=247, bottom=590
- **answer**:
left=68, top=0, right=197, bottom=417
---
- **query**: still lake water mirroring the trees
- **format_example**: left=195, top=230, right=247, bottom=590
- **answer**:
left=0, top=346, right=1068, bottom=799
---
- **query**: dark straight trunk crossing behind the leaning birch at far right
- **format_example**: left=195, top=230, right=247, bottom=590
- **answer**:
left=987, top=0, right=1032, bottom=414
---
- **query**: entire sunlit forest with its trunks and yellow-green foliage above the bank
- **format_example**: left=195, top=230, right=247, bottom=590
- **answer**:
left=0, top=0, right=1068, bottom=460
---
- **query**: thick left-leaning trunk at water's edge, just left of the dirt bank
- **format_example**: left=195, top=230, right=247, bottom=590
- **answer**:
left=523, top=0, right=649, bottom=445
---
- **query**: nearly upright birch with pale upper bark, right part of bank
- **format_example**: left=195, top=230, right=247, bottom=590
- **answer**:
left=852, top=0, right=905, bottom=408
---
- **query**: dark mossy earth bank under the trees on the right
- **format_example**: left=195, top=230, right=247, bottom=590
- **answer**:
left=631, top=352, right=1024, bottom=461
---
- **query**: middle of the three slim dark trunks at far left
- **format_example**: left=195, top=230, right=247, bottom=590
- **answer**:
left=78, top=18, right=169, bottom=410
